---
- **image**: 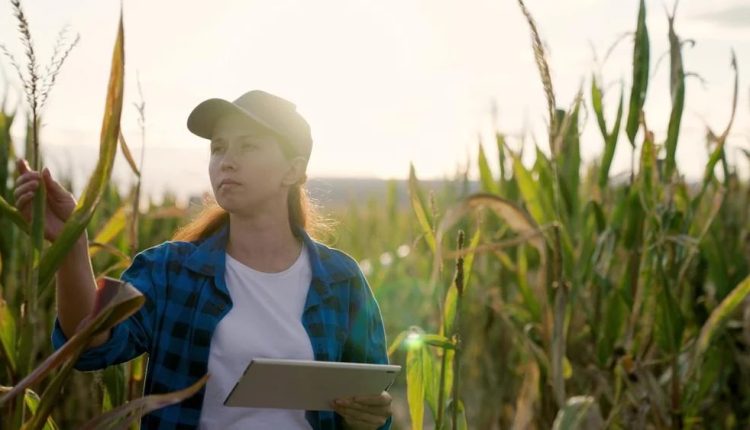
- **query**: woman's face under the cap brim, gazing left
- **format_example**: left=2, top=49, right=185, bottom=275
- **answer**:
left=208, top=115, right=304, bottom=214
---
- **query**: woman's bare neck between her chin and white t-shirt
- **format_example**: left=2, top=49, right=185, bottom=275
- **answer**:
left=227, top=206, right=302, bottom=272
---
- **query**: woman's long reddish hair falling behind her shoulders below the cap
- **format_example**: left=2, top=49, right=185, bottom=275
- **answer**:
left=172, top=183, right=331, bottom=242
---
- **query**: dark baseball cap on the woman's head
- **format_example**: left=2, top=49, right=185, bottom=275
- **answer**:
left=187, top=90, right=312, bottom=158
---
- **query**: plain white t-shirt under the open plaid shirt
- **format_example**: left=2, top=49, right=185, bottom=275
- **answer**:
left=199, top=246, right=314, bottom=430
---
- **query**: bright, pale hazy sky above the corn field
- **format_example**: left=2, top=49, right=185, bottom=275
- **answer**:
left=0, top=0, right=750, bottom=205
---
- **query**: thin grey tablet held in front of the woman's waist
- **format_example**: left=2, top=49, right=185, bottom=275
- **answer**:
left=224, top=358, right=401, bottom=411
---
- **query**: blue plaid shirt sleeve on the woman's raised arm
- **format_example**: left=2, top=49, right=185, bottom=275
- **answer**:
left=52, top=246, right=165, bottom=371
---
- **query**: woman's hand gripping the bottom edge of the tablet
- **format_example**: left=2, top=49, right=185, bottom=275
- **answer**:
left=332, top=391, right=393, bottom=430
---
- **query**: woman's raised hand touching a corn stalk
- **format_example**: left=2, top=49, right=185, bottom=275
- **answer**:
left=13, top=159, right=77, bottom=242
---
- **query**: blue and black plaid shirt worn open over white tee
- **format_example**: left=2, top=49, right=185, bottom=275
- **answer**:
left=52, top=225, right=391, bottom=430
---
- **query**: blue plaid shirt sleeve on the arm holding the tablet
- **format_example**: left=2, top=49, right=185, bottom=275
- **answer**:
left=344, top=267, right=393, bottom=430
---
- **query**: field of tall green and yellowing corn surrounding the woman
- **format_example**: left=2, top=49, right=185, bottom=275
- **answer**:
left=0, top=0, right=750, bottom=429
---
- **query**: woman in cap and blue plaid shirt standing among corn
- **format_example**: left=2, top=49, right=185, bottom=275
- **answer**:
left=15, top=91, right=391, bottom=429
